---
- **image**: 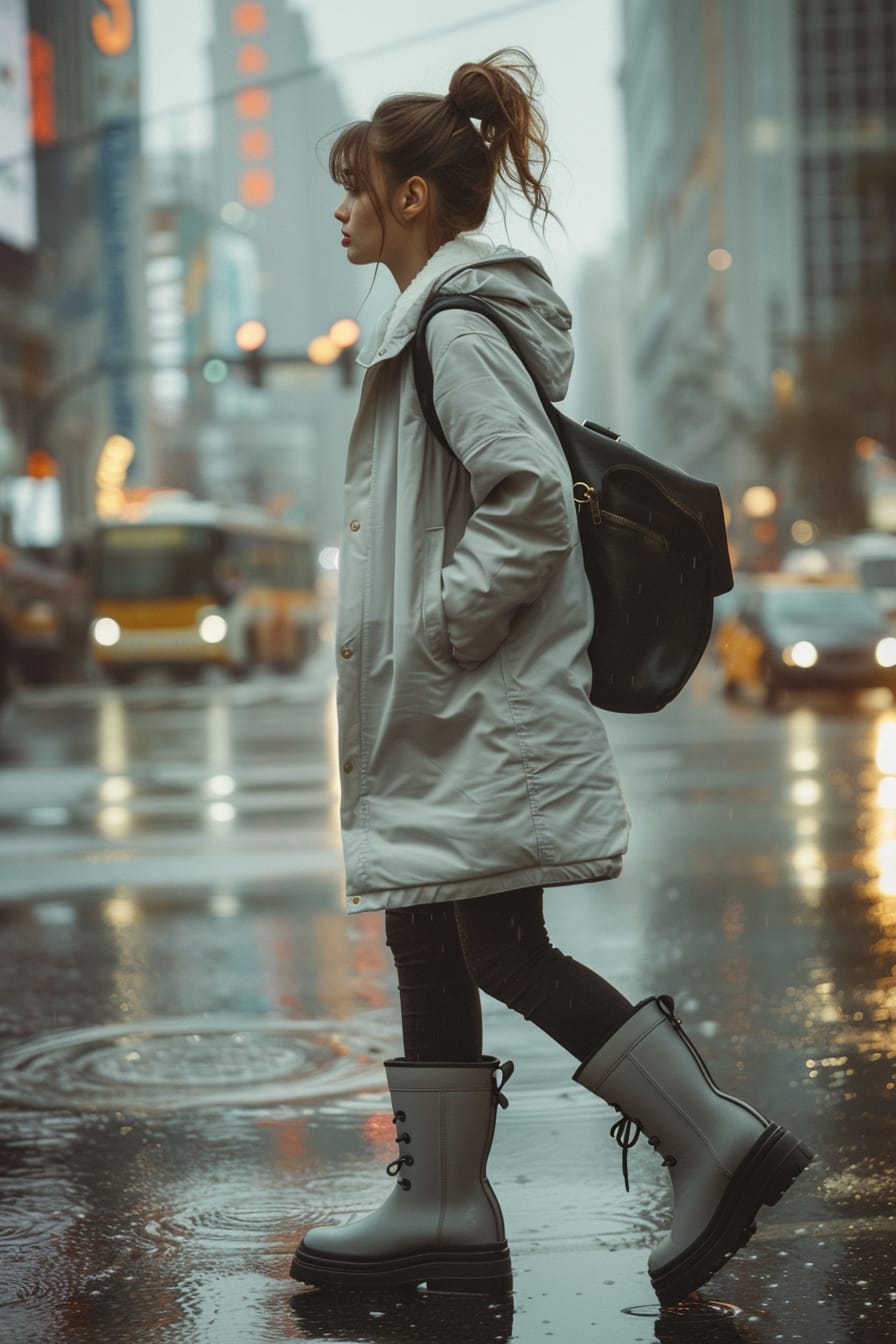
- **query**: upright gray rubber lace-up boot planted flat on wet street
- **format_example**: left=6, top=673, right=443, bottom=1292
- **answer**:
left=290, top=1058, right=513, bottom=1293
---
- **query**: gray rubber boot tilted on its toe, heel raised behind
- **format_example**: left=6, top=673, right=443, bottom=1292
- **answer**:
left=574, top=995, right=814, bottom=1306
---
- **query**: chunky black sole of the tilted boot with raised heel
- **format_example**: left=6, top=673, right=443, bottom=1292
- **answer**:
left=650, top=1125, right=815, bottom=1306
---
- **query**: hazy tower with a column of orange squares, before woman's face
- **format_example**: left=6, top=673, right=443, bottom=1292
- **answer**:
left=197, top=0, right=364, bottom=543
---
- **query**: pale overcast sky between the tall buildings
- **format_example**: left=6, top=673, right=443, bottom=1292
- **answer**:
left=140, top=0, right=625, bottom=298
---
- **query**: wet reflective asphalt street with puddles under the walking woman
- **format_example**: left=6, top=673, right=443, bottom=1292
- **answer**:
left=0, top=659, right=896, bottom=1344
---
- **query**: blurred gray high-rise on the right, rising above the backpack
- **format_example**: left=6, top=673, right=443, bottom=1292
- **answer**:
left=621, top=0, right=896, bottom=551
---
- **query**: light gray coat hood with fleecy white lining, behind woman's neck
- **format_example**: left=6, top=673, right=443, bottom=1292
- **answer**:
left=357, top=234, right=574, bottom=402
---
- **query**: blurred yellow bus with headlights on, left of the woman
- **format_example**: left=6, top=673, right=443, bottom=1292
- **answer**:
left=90, top=497, right=320, bottom=684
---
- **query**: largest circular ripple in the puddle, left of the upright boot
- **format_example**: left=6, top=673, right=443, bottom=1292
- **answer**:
left=0, top=1017, right=383, bottom=1114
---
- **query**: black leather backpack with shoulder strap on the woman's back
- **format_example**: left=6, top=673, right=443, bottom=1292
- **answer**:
left=411, top=293, right=733, bottom=714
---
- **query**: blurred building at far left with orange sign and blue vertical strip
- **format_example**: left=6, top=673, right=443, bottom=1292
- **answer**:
left=0, top=0, right=150, bottom=542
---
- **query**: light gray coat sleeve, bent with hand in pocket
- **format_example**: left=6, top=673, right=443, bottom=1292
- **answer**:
left=427, top=313, right=576, bottom=668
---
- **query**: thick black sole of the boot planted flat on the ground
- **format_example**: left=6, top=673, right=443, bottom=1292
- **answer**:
left=289, top=1242, right=513, bottom=1293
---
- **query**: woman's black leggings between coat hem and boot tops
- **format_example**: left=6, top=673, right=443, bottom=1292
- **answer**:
left=386, top=887, right=634, bottom=1063
